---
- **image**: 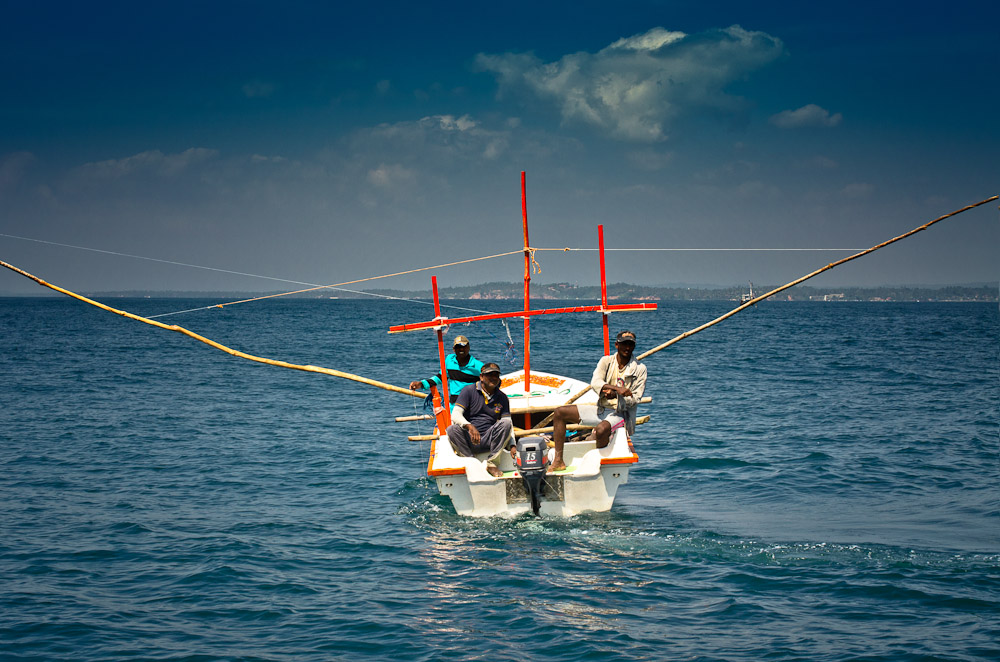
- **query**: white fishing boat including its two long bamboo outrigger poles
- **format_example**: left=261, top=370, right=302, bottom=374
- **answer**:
left=0, top=178, right=988, bottom=517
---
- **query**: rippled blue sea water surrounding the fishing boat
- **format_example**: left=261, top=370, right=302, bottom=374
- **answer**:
left=0, top=298, right=1000, bottom=661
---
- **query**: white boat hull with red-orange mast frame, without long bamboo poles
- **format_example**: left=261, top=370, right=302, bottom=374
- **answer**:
left=389, top=172, right=657, bottom=517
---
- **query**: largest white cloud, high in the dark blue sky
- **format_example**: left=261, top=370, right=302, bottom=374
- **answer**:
left=476, top=25, right=784, bottom=142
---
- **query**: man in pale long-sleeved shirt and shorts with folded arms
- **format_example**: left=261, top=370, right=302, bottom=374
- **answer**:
left=549, top=331, right=646, bottom=473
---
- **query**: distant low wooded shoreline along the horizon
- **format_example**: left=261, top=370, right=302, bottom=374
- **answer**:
left=0, top=283, right=1000, bottom=302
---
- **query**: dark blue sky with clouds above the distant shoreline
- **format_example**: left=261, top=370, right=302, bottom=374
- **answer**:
left=0, top=0, right=1000, bottom=294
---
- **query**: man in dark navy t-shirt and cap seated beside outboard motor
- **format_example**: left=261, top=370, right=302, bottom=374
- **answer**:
left=448, top=364, right=514, bottom=478
